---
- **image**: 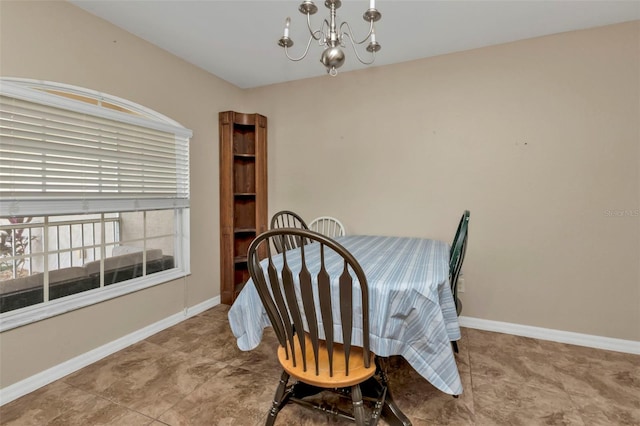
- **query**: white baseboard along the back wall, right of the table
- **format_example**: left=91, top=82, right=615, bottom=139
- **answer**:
left=459, top=316, right=640, bottom=355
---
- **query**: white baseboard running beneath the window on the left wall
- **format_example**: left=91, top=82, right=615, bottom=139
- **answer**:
left=0, top=296, right=220, bottom=406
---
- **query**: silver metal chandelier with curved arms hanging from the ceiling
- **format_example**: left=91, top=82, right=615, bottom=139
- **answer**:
left=278, top=0, right=382, bottom=77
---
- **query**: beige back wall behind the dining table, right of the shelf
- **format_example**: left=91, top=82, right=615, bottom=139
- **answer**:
left=250, top=22, right=640, bottom=341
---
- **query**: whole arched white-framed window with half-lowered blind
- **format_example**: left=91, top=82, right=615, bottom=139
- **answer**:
left=0, top=78, right=191, bottom=330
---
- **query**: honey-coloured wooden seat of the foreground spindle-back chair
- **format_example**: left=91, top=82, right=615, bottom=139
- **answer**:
left=278, top=334, right=376, bottom=388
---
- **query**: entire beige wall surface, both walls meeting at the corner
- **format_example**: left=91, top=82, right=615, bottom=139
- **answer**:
left=0, top=1, right=640, bottom=387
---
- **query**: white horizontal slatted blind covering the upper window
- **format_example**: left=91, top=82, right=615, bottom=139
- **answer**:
left=0, top=80, right=190, bottom=216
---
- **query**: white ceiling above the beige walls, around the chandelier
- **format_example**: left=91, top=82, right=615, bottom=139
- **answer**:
left=69, top=0, right=640, bottom=88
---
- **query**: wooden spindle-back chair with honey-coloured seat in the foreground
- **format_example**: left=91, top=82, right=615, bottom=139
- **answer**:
left=248, top=228, right=387, bottom=425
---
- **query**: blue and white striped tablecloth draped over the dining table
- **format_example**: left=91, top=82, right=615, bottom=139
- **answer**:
left=229, top=235, right=462, bottom=395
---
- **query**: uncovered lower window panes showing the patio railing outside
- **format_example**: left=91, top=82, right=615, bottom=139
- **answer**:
left=0, top=210, right=176, bottom=313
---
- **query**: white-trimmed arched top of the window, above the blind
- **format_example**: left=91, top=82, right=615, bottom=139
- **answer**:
left=0, top=77, right=192, bottom=139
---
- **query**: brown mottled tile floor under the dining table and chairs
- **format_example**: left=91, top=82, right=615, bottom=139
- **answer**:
left=0, top=305, right=640, bottom=426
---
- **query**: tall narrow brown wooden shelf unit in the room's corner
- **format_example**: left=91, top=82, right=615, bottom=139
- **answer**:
left=219, top=111, right=267, bottom=305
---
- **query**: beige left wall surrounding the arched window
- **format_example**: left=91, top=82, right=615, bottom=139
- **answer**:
left=0, top=0, right=245, bottom=387
